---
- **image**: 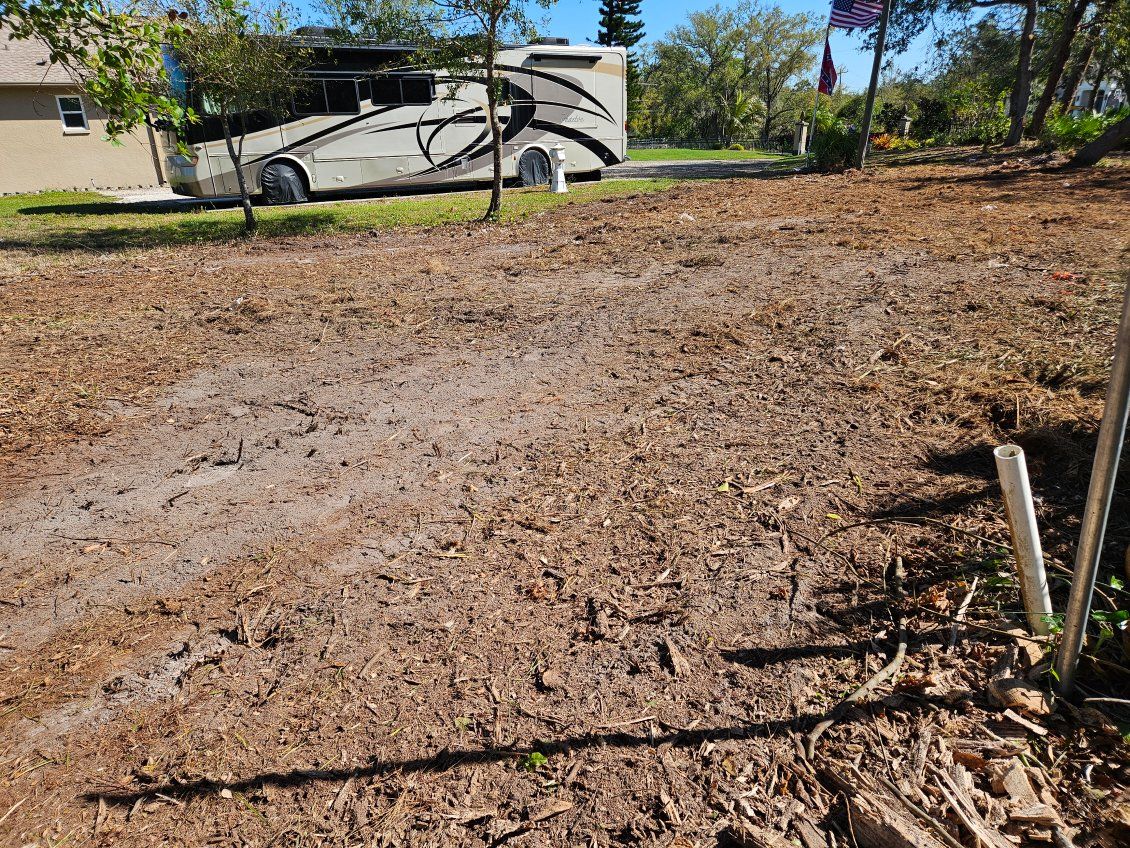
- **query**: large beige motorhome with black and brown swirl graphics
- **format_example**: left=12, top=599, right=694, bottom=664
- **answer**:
left=164, top=40, right=627, bottom=204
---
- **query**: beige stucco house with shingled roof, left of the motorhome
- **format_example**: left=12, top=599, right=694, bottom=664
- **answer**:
left=0, top=31, right=163, bottom=194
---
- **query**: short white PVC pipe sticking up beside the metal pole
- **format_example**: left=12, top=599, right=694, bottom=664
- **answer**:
left=992, top=444, right=1052, bottom=635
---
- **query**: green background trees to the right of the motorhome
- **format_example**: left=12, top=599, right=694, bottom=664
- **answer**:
left=632, top=0, right=1130, bottom=154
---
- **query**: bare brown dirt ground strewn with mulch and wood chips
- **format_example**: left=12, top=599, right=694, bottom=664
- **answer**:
left=0, top=156, right=1130, bottom=848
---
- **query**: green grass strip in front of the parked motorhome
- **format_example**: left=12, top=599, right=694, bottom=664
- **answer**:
left=0, top=180, right=676, bottom=252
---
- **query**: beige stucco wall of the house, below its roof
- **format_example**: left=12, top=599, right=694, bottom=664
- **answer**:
left=0, top=83, right=158, bottom=194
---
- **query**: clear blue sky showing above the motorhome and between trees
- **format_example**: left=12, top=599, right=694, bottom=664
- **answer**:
left=297, top=0, right=949, bottom=90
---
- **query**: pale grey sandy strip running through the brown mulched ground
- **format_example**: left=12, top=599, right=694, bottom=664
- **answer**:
left=0, top=241, right=768, bottom=687
